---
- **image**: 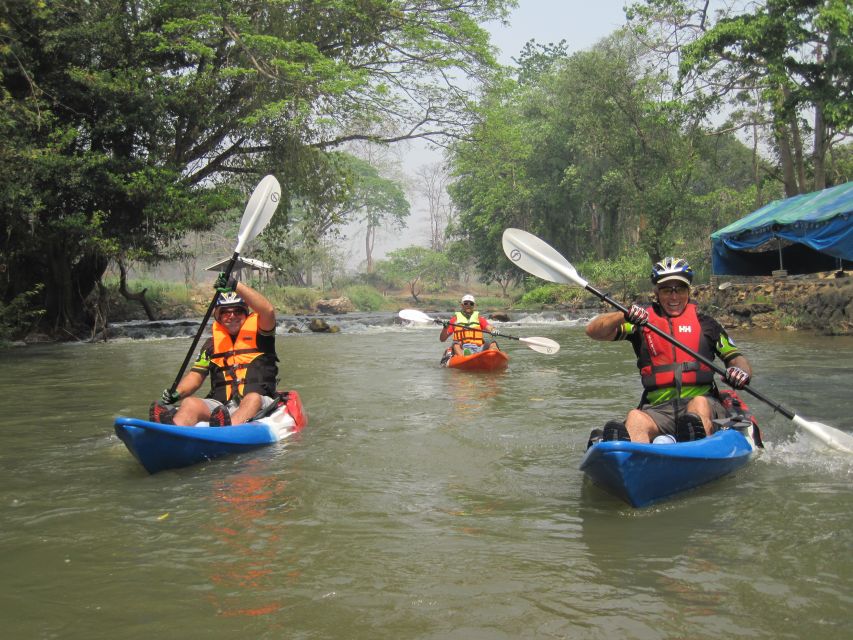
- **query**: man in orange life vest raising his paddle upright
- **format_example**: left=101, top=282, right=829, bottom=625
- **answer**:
left=149, top=274, right=278, bottom=426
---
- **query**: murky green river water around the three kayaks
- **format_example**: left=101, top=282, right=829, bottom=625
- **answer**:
left=0, top=314, right=853, bottom=640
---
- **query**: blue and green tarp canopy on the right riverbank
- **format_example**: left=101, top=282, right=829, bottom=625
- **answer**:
left=711, top=182, right=853, bottom=275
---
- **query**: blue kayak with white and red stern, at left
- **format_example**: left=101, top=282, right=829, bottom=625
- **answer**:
left=114, top=391, right=307, bottom=473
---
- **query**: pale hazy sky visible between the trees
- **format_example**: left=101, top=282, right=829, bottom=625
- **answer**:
left=346, top=0, right=625, bottom=266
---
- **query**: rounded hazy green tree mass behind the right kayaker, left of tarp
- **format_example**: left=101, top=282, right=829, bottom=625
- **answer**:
left=451, top=33, right=764, bottom=278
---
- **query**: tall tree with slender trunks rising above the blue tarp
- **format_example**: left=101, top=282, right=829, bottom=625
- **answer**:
left=629, top=0, right=853, bottom=196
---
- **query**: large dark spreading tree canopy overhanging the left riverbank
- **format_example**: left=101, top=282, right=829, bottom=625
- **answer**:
left=0, top=0, right=515, bottom=338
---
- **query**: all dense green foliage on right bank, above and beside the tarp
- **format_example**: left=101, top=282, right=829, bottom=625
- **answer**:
left=451, top=0, right=853, bottom=279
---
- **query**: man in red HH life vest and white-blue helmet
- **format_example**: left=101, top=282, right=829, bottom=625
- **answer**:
left=586, top=257, right=752, bottom=442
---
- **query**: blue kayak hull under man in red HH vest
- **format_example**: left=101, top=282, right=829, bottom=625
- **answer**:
left=580, top=429, right=754, bottom=507
